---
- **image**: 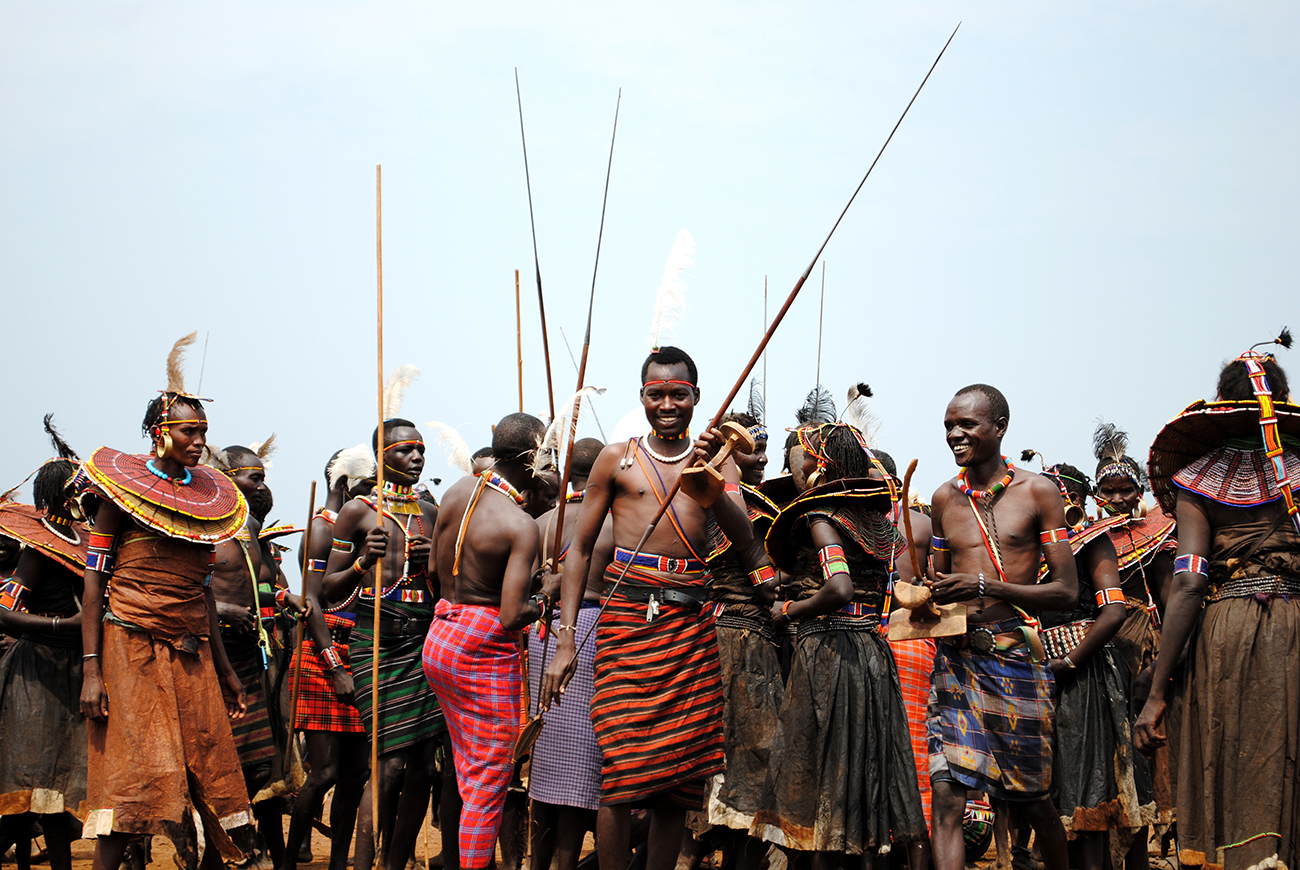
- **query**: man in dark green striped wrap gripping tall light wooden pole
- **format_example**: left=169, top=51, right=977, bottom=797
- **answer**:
left=324, top=417, right=445, bottom=870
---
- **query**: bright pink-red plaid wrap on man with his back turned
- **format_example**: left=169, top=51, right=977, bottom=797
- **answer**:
left=424, top=600, right=514, bottom=870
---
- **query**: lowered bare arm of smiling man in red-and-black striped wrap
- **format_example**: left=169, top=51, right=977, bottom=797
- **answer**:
left=538, top=445, right=623, bottom=710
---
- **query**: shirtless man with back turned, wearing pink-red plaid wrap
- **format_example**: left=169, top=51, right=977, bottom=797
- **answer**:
left=424, top=414, right=546, bottom=870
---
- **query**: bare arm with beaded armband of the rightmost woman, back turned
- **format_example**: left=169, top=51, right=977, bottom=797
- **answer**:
left=1134, top=489, right=1212, bottom=753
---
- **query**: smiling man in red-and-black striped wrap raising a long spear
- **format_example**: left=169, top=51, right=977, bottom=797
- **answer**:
left=542, top=347, right=766, bottom=870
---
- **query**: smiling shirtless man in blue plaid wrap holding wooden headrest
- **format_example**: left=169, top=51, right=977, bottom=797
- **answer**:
left=928, top=384, right=1079, bottom=870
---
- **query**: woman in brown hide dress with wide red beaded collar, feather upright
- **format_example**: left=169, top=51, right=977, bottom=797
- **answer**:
left=81, top=334, right=252, bottom=870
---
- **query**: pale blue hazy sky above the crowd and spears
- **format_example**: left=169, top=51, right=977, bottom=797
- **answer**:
left=0, top=3, right=1300, bottom=582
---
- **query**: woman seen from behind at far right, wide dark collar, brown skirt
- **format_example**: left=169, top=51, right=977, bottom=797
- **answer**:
left=1135, top=330, right=1300, bottom=870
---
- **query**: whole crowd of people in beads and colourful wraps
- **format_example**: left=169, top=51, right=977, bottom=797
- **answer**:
left=0, top=332, right=1300, bottom=870
